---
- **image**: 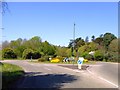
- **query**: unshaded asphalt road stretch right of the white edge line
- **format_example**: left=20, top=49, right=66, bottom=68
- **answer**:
left=88, top=62, right=120, bottom=86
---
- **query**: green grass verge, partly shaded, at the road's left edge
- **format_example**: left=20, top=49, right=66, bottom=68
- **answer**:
left=0, top=63, right=24, bottom=88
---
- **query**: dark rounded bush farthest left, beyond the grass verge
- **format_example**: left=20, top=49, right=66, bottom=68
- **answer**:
left=2, top=48, right=17, bottom=59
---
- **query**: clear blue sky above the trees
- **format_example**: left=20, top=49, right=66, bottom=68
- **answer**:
left=2, top=2, right=118, bottom=46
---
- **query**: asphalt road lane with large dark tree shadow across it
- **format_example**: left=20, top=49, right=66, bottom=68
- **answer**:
left=0, top=60, right=116, bottom=89
